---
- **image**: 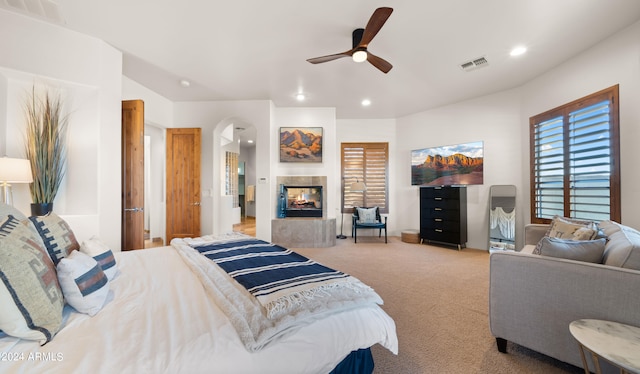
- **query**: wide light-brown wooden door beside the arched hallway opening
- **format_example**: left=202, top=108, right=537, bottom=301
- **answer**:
left=167, top=128, right=202, bottom=243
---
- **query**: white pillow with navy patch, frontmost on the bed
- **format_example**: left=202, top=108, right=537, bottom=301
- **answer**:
left=57, top=251, right=109, bottom=316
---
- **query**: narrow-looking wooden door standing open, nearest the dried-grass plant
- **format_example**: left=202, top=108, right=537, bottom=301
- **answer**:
left=122, top=100, right=144, bottom=250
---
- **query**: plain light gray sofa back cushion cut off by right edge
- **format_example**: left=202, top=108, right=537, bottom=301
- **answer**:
left=602, top=221, right=640, bottom=270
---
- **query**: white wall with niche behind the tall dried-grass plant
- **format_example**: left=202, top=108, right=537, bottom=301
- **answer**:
left=0, top=10, right=122, bottom=250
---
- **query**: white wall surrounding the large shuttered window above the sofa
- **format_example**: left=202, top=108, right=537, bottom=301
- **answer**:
left=520, top=22, right=640, bottom=228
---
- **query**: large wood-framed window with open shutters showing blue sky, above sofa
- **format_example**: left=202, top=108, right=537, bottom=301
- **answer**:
left=529, top=85, right=620, bottom=223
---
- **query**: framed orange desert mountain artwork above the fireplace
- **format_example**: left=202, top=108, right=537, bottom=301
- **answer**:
left=280, top=127, right=322, bottom=162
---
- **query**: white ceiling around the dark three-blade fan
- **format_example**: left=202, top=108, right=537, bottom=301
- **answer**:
left=0, top=0, right=640, bottom=119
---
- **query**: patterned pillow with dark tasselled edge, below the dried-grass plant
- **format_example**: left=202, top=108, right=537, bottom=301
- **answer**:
left=29, top=212, right=80, bottom=265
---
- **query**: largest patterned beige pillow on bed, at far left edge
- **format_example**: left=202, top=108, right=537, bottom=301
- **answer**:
left=0, top=216, right=64, bottom=344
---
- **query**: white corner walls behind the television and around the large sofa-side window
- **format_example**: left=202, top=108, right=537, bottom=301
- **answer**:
left=396, top=22, right=640, bottom=248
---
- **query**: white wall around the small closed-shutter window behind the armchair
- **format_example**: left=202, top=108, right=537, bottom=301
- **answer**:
left=334, top=119, right=398, bottom=238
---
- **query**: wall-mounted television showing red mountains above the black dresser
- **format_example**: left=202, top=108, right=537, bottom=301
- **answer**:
left=411, top=141, right=484, bottom=186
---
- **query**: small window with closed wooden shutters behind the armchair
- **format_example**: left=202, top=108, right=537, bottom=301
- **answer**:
left=342, top=143, right=389, bottom=213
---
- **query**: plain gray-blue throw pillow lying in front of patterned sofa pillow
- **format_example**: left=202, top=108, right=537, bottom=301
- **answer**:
left=540, top=237, right=607, bottom=264
